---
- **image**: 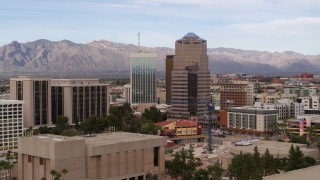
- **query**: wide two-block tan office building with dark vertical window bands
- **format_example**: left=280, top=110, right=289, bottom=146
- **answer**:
left=10, top=77, right=109, bottom=128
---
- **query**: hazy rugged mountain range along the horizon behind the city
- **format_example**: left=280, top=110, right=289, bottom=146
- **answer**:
left=0, top=39, right=320, bottom=76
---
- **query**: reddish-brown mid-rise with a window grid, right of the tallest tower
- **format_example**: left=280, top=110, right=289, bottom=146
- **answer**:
left=220, top=83, right=254, bottom=110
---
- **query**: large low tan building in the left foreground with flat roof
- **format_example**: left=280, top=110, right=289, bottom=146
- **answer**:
left=18, top=132, right=166, bottom=180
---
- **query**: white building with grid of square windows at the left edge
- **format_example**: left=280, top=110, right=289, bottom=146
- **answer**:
left=0, top=100, right=23, bottom=153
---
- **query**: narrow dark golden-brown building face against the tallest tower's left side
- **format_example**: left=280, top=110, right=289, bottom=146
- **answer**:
left=166, top=55, right=174, bottom=105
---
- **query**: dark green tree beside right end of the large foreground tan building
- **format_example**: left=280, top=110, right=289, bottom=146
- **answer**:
left=165, top=145, right=201, bottom=179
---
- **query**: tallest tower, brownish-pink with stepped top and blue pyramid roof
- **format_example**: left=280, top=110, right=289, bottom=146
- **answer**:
left=171, top=33, right=210, bottom=118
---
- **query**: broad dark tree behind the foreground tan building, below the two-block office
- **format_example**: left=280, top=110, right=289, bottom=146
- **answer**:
left=80, top=116, right=106, bottom=134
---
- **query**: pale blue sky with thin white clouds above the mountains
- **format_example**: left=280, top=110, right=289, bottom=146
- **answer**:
left=0, top=0, right=320, bottom=55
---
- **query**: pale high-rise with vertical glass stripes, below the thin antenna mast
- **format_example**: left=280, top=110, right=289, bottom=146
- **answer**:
left=130, top=52, right=157, bottom=104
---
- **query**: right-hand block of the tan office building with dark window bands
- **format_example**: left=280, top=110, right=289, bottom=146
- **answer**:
left=51, top=79, right=109, bottom=124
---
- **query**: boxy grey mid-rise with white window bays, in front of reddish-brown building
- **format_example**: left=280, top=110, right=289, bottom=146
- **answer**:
left=227, top=107, right=278, bottom=133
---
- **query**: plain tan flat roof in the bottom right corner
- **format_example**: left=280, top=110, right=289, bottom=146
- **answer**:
left=263, top=165, right=320, bottom=180
